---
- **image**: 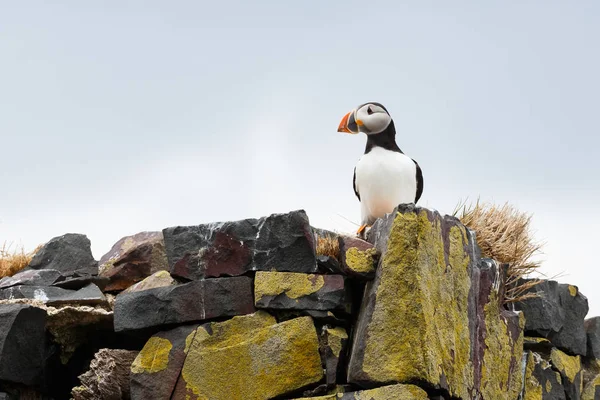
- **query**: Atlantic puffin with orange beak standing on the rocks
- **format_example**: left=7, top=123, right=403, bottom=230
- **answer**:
left=338, top=102, right=423, bottom=236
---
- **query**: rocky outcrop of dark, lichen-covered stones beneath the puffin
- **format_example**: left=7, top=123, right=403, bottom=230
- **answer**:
left=0, top=205, right=600, bottom=400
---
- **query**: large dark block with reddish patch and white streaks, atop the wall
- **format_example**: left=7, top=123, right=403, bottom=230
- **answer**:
left=163, top=211, right=317, bottom=280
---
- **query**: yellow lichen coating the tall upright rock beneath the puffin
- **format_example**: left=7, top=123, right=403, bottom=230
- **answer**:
left=352, top=211, right=473, bottom=398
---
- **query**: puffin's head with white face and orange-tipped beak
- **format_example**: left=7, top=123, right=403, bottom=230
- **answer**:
left=338, top=102, right=392, bottom=135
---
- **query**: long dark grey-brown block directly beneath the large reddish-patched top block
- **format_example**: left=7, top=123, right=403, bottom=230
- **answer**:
left=114, top=276, right=255, bottom=332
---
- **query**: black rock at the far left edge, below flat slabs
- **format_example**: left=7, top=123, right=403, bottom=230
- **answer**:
left=0, top=304, right=46, bottom=386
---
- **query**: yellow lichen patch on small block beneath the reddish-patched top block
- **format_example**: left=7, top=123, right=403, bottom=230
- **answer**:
left=254, top=271, right=325, bottom=301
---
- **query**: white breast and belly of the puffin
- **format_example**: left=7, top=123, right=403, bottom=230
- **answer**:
left=356, top=147, right=417, bottom=224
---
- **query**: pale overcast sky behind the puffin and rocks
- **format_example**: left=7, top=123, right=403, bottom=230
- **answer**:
left=0, top=0, right=600, bottom=315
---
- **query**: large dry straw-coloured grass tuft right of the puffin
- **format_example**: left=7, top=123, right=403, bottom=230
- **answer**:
left=454, top=201, right=543, bottom=303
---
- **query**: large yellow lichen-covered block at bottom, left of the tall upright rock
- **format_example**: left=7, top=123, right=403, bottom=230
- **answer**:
left=173, top=317, right=323, bottom=400
